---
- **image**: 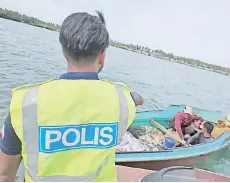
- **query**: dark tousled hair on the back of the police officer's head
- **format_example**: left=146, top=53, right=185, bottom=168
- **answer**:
left=59, top=11, right=109, bottom=64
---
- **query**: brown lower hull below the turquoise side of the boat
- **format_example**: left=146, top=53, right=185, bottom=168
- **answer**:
left=116, top=153, right=211, bottom=170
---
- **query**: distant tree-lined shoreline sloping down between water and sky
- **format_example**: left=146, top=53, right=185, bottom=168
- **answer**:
left=0, top=8, right=230, bottom=76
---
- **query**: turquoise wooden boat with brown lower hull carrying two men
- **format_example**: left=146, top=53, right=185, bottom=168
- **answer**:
left=116, top=105, right=230, bottom=170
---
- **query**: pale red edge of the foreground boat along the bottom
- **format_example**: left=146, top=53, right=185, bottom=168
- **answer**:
left=117, top=166, right=230, bottom=182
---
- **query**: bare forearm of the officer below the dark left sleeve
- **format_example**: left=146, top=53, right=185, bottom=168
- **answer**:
left=0, top=152, right=22, bottom=182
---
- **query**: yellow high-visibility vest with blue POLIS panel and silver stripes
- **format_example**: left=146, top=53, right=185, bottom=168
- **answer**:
left=10, top=79, right=136, bottom=182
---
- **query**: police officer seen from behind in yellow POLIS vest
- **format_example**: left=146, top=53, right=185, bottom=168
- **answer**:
left=0, top=12, right=143, bottom=182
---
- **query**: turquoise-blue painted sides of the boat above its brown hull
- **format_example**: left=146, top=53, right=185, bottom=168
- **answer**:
left=116, top=105, right=230, bottom=163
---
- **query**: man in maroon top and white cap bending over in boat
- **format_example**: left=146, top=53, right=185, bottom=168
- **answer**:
left=169, top=106, right=204, bottom=139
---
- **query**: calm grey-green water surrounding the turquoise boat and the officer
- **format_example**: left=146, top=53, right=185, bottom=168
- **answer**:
left=0, top=19, right=230, bottom=175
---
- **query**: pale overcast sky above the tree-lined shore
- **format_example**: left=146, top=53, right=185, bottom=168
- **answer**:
left=0, top=0, right=230, bottom=67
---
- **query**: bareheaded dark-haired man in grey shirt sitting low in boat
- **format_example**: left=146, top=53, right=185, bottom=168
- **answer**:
left=187, top=122, right=214, bottom=144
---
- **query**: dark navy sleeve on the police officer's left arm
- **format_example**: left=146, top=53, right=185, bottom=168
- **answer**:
left=0, top=113, right=22, bottom=155
